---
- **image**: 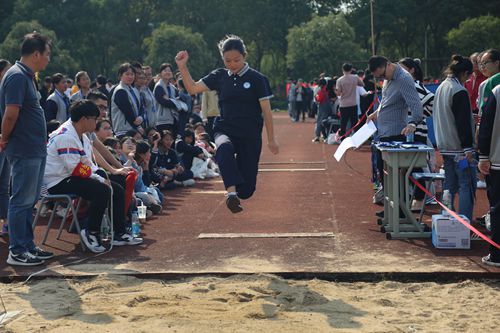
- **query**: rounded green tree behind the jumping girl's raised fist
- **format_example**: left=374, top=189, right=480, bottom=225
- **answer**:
left=144, top=24, right=214, bottom=78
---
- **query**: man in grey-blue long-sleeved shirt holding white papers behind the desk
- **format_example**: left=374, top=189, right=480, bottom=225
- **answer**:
left=368, top=56, right=423, bottom=217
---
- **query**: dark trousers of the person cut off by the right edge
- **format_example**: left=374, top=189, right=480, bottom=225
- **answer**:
left=488, top=170, right=500, bottom=262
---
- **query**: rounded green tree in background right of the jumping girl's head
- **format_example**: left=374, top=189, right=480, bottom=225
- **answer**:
left=287, top=14, right=366, bottom=79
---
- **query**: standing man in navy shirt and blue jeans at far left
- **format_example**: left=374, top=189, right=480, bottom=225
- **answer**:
left=0, top=33, right=54, bottom=266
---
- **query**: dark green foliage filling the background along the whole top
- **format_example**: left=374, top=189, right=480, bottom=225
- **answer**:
left=0, top=0, right=500, bottom=81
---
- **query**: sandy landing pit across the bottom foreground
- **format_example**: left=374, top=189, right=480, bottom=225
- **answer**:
left=0, top=275, right=500, bottom=333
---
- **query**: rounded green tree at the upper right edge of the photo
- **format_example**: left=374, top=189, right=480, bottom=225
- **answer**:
left=446, top=15, right=500, bottom=55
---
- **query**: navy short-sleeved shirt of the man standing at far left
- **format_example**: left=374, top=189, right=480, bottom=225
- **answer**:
left=0, top=61, right=47, bottom=157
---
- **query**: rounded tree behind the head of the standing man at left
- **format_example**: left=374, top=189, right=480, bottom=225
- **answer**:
left=0, top=21, right=79, bottom=74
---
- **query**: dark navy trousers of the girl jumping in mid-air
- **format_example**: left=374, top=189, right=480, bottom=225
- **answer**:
left=215, top=133, right=262, bottom=199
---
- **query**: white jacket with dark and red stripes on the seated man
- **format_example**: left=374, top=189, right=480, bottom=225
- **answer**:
left=43, top=119, right=104, bottom=189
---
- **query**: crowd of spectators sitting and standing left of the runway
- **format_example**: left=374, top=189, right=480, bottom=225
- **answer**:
left=0, top=33, right=219, bottom=265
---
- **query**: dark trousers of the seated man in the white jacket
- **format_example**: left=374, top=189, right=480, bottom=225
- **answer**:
left=49, top=177, right=125, bottom=234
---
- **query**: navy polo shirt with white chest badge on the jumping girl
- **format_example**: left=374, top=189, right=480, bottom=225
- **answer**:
left=202, top=64, right=273, bottom=138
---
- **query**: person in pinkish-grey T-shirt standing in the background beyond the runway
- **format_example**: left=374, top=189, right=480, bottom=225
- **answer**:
left=336, top=63, right=365, bottom=136
